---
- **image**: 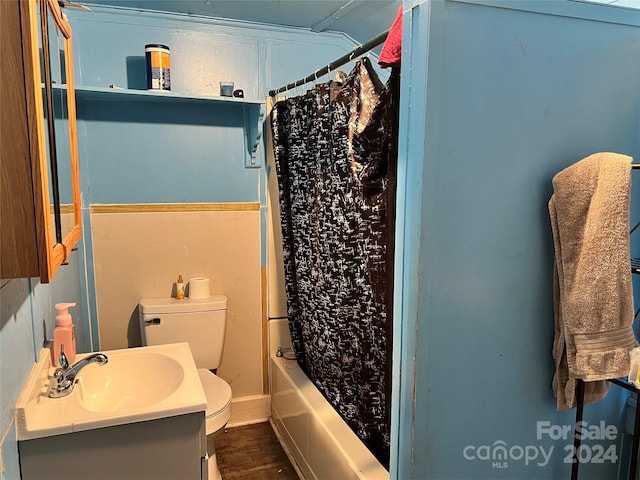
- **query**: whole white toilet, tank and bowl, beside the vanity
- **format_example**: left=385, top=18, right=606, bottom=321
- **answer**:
left=138, top=295, right=231, bottom=480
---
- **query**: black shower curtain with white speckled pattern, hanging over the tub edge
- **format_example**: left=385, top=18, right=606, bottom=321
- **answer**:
left=272, top=58, right=397, bottom=466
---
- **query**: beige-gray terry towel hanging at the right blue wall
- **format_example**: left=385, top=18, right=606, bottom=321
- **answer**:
left=549, top=153, right=637, bottom=410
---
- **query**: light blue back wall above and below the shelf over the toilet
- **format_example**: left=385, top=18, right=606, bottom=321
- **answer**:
left=71, top=7, right=364, bottom=204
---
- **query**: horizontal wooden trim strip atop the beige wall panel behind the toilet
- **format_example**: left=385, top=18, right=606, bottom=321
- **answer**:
left=89, top=202, right=260, bottom=213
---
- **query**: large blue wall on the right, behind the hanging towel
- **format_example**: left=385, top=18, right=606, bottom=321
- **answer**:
left=394, top=0, right=640, bottom=479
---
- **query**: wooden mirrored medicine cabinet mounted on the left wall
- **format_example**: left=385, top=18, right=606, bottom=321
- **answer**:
left=0, top=0, right=82, bottom=283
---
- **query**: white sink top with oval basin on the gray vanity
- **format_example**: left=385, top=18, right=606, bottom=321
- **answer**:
left=16, top=343, right=206, bottom=440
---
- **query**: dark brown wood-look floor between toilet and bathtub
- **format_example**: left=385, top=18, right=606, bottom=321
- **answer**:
left=215, top=422, right=300, bottom=480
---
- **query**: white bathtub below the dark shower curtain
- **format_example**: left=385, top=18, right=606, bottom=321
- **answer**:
left=270, top=355, right=389, bottom=480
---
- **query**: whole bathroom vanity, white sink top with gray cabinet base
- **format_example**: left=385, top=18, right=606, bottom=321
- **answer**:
left=16, top=343, right=208, bottom=480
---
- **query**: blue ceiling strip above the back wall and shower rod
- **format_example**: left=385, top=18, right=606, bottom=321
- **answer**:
left=79, top=0, right=402, bottom=43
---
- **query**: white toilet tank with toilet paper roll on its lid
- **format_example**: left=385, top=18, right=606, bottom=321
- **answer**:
left=138, top=295, right=227, bottom=370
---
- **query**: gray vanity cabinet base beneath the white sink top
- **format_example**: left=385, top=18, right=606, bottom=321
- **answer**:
left=18, top=412, right=207, bottom=480
